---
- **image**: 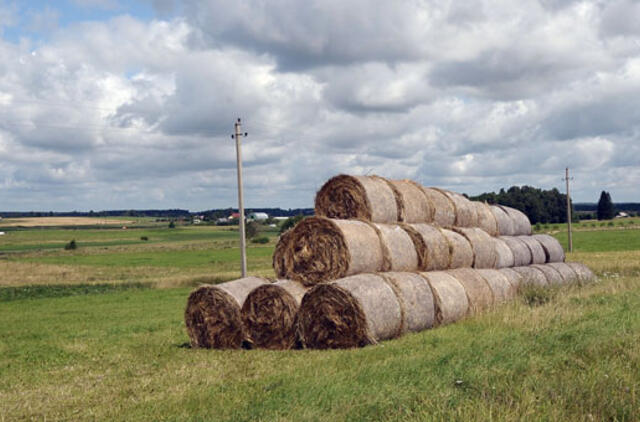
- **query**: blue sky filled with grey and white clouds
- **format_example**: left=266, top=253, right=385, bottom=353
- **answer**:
left=0, top=0, right=640, bottom=211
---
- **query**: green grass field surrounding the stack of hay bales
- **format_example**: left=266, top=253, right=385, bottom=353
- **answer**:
left=0, top=223, right=640, bottom=420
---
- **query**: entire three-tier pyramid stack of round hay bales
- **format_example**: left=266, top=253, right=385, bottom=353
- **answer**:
left=185, top=175, right=594, bottom=349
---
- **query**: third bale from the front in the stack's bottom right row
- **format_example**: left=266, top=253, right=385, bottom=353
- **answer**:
left=420, top=271, right=469, bottom=325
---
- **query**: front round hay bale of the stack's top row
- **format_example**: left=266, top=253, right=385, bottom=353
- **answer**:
left=315, top=174, right=400, bottom=223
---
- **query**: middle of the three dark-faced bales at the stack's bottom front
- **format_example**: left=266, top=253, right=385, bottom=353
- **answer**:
left=242, top=280, right=308, bottom=350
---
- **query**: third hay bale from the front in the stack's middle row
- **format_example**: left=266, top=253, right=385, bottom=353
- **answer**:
left=405, top=224, right=449, bottom=271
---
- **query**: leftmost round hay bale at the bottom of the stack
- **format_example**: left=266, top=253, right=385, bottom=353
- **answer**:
left=184, top=277, right=267, bottom=349
